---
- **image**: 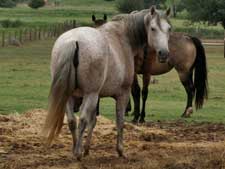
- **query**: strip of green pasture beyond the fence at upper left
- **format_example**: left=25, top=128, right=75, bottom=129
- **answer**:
left=0, top=0, right=116, bottom=27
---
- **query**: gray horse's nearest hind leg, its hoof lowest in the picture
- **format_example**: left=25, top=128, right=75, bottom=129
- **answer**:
left=74, top=93, right=98, bottom=160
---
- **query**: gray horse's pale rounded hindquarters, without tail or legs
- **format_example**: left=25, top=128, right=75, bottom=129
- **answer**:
left=51, top=27, right=108, bottom=93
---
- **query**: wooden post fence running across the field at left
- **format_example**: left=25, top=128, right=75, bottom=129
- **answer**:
left=0, top=20, right=76, bottom=47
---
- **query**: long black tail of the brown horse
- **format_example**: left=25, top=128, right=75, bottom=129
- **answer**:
left=191, top=37, right=208, bottom=109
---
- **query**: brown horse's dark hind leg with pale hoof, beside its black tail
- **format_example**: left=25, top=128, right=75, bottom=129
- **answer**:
left=179, top=73, right=195, bottom=117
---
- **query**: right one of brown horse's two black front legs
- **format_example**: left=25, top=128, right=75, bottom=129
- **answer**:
left=139, top=74, right=150, bottom=123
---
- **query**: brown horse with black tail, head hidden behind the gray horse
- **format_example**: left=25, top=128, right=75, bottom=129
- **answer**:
left=132, top=33, right=208, bottom=123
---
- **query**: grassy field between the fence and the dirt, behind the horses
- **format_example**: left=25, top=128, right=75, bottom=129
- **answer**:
left=0, top=40, right=225, bottom=122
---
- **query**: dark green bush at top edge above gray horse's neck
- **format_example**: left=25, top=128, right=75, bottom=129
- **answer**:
left=116, top=0, right=144, bottom=13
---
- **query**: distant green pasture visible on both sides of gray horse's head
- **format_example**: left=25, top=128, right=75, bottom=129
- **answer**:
left=0, top=0, right=224, bottom=39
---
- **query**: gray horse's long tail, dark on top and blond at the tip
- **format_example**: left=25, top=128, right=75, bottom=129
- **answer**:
left=43, top=42, right=79, bottom=144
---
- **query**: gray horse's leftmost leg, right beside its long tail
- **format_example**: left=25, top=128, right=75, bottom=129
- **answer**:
left=66, top=97, right=77, bottom=152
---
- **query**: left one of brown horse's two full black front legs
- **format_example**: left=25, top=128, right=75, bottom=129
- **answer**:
left=132, top=74, right=141, bottom=123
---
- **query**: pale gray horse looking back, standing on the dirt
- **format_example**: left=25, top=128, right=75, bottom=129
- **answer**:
left=43, top=7, right=171, bottom=160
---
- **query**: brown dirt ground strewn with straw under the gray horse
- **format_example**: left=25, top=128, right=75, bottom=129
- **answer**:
left=0, top=110, right=225, bottom=169
